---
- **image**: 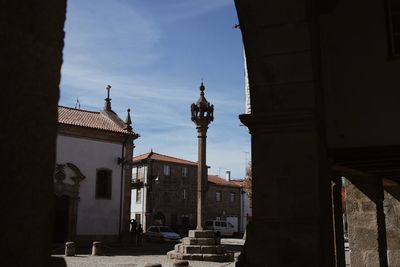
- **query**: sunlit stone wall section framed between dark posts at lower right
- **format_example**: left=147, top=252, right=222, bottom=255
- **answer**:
left=345, top=176, right=387, bottom=267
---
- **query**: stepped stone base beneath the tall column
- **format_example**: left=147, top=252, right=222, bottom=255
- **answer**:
left=167, top=230, right=234, bottom=262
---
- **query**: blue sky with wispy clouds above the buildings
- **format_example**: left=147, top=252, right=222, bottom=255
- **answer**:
left=59, top=0, right=250, bottom=178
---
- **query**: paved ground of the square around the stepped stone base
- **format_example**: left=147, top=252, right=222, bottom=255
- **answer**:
left=53, top=239, right=243, bottom=267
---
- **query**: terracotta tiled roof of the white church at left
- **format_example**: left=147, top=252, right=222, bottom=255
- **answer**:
left=58, top=106, right=135, bottom=135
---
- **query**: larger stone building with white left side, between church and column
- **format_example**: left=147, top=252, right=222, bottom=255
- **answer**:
left=131, top=151, right=197, bottom=233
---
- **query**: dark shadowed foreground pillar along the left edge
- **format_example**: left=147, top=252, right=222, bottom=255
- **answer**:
left=0, top=0, right=66, bottom=267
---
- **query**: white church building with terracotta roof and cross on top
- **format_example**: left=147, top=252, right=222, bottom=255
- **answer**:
left=53, top=92, right=138, bottom=245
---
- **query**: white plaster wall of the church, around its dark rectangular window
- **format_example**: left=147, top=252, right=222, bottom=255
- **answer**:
left=56, top=135, right=122, bottom=235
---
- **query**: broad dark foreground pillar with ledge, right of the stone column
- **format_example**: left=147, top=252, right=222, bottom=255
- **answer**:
left=235, top=0, right=335, bottom=267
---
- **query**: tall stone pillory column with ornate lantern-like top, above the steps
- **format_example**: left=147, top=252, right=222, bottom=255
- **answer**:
left=191, top=82, right=214, bottom=230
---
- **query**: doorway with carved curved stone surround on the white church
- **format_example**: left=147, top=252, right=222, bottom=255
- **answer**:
left=53, top=163, right=85, bottom=241
